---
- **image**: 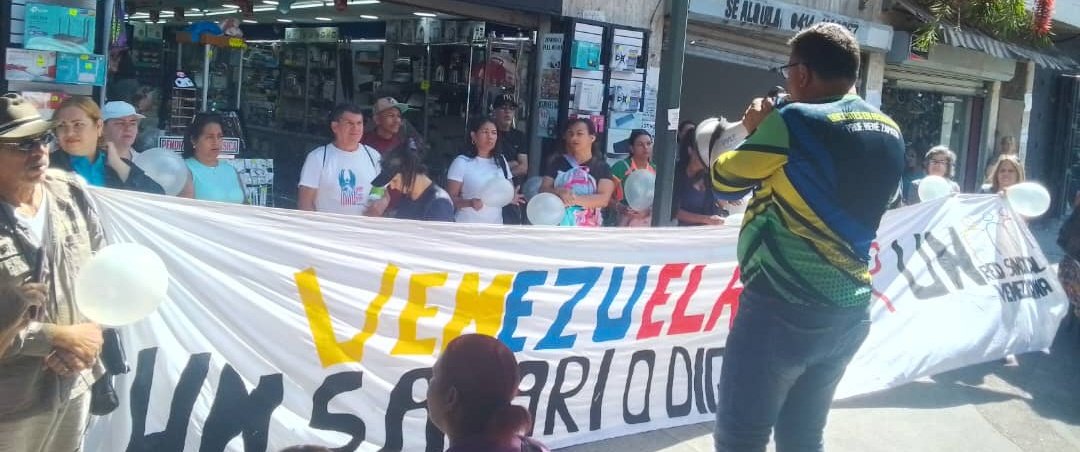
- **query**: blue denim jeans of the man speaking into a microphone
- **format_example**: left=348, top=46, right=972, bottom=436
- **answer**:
left=714, top=291, right=870, bottom=452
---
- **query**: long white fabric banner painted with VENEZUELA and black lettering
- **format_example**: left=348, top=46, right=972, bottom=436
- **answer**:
left=86, top=190, right=1067, bottom=452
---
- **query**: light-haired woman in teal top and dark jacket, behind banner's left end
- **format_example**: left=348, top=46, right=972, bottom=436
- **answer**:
left=52, top=96, right=165, bottom=194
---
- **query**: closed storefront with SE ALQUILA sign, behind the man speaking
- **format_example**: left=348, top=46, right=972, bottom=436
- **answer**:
left=681, top=0, right=892, bottom=122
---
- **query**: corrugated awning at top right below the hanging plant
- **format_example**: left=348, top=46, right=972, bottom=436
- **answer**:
left=896, top=0, right=1080, bottom=70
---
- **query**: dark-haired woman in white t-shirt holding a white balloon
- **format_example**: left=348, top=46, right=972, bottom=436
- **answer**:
left=446, top=118, right=513, bottom=224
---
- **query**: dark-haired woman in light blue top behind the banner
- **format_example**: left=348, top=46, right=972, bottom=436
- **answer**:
left=180, top=113, right=244, bottom=204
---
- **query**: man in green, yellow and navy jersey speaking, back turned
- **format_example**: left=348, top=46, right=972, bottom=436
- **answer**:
left=712, top=23, right=904, bottom=452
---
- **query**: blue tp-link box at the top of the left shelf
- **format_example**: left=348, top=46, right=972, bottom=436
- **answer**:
left=24, top=3, right=97, bottom=53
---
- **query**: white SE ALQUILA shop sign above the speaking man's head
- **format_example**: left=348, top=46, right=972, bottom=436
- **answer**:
left=690, top=0, right=892, bottom=52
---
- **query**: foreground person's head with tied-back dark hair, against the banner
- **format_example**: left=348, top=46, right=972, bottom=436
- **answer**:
left=428, top=334, right=548, bottom=452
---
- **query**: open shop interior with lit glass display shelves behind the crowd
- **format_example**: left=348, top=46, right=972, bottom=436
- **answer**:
left=109, top=0, right=559, bottom=207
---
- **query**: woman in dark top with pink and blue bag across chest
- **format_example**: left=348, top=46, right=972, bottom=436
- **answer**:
left=540, top=118, right=615, bottom=227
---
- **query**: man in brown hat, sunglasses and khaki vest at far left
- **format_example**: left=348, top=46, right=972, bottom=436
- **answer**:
left=0, top=94, right=105, bottom=451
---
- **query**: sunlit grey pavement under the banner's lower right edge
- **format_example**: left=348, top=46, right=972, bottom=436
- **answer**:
left=562, top=220, right=1080, bottom=452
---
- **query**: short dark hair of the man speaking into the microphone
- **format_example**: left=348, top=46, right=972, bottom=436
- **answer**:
left=788, top=22, right=860, bottom=81
